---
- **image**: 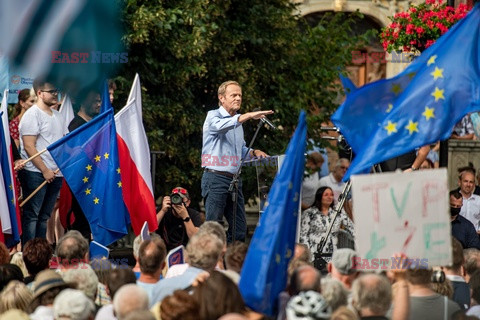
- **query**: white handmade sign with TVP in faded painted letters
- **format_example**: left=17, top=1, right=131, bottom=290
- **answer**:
left=352, top=168, right=452, bottom=269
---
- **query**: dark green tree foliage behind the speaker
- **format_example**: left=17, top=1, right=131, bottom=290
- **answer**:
left=117, top=0, right=370, bottom=204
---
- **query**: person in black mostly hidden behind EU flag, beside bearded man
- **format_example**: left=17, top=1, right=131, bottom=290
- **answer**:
left=68, top=91, right=102, bottom=240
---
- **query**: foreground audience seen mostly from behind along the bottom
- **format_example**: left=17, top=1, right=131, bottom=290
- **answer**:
left=0, top=229, right=480, bottom=320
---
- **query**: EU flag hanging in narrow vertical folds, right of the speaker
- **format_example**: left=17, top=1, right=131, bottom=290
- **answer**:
left=239, top=111, right=307, bottom=316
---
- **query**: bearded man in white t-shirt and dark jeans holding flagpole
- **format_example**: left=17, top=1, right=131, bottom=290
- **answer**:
left=19, top=79, right=65, bottom=244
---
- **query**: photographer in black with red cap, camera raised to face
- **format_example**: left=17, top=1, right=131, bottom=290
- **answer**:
left=156, top=187, right=202, bottom=251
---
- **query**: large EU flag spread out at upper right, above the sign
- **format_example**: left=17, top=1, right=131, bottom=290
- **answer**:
left=332, top=5, right=480, bottom=180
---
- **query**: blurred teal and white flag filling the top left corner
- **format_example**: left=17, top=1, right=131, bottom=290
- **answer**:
left=0, top=0, right=128, bottom=100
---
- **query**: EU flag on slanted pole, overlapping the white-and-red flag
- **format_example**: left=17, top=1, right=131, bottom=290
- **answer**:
left=47, top=109, right=130, bottom=245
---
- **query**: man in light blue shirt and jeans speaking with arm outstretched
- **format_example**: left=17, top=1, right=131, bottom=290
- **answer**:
left=202, top=81, right=273, bottom=242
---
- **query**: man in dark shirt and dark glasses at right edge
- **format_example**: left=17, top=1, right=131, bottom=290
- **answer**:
left=450, top=190, right=480, bottom=249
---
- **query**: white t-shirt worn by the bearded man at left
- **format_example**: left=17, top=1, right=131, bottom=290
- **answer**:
left=19, top=104, right=66, bottom=177
